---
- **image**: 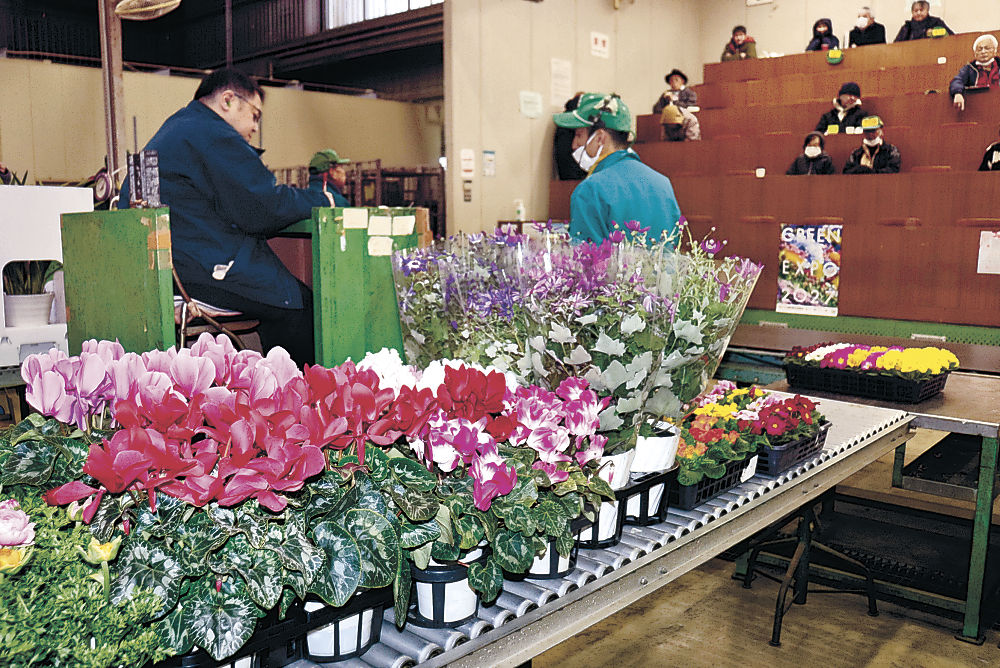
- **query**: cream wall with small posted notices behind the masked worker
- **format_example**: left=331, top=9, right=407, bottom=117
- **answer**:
left=445, top=0, right=701, bottom=233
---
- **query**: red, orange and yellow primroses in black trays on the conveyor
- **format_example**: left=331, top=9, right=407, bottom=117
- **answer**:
left=677, top=380, right=826, bottom=485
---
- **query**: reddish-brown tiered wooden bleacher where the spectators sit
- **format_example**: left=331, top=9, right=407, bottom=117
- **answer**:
left=549, top=32, right=1000, bottom=327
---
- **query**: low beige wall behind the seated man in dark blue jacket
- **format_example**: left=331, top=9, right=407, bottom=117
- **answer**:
left=0, top=58, right=442, bottom=181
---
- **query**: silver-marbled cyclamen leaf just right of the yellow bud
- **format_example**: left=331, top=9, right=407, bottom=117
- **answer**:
left=111, top=542, right=184, bottom=610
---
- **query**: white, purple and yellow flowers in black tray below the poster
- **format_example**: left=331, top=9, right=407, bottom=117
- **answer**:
left=785, top=343, right=959, bottom=381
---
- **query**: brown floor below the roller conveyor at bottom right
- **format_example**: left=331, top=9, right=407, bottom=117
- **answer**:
left=532, top=559, right=1000, bottom=668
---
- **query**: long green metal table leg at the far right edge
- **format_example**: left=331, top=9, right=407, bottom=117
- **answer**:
left=956, top=437, right=998, bottom=644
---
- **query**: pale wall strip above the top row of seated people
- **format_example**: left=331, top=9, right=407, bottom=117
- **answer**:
left=698, top=0, right=1000, bottom=65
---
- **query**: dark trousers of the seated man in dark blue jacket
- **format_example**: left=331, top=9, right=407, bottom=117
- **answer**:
left=184, top=281, right=316, bottom=366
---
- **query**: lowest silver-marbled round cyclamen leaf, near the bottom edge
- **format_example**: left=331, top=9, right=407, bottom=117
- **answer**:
left=184, top=580, right=258, bottom=661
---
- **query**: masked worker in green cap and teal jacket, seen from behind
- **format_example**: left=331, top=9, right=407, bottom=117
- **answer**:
left=553, top=93, right=681, bottom=243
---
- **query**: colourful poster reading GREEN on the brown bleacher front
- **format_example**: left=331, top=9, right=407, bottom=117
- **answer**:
left=774, top=224, right=843, bottom=316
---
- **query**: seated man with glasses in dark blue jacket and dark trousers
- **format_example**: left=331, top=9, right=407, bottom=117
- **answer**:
left=121, top=68, right=332, bottom=364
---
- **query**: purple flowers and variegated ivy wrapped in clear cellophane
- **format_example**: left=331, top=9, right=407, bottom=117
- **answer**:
left=394, top=221, right=760, bottom=453
